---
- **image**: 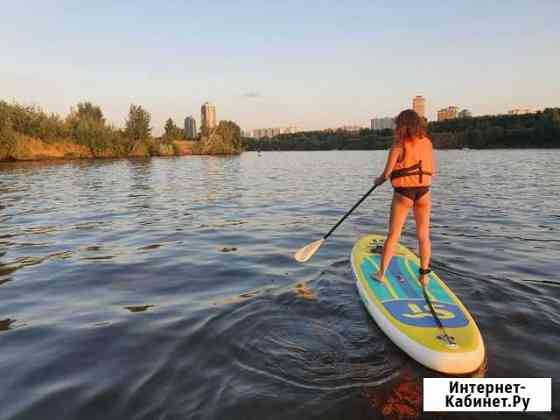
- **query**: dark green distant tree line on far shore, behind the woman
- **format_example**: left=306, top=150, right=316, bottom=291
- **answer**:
left=244, top=108, right=560, bottom=150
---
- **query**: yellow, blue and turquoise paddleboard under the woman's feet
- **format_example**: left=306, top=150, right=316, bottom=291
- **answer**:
left=351, top=235, right=484, bottom=374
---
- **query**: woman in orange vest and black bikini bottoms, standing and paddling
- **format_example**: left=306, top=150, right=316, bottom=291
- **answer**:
left=375, top=109, right=436, bottom=285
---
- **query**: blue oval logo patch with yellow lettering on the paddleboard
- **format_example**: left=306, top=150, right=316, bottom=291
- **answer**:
left=383, top=299, right=469, bottom=328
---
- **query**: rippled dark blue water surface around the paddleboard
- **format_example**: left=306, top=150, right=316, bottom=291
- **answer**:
left=0, top=150, right=560, bottom=420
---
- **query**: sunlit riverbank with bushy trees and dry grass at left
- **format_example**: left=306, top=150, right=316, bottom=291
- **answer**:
left=0, top=101, right=243, bottom=161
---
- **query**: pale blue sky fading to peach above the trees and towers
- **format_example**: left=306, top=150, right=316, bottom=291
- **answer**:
left=0, top=0, right=560, bottom=134
